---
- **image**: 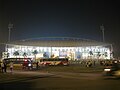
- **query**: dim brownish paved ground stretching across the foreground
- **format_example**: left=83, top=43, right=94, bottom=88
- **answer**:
left=0, top=71, right=120, bottom=90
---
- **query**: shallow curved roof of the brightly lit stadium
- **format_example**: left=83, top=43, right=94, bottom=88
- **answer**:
left=9, top=37, right=110, bottom=47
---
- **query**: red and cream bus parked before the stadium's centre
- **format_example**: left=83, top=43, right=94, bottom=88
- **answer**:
left=39, top=58, right=69, bottom=66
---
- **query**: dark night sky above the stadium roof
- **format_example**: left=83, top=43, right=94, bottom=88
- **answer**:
left=0, top=0, right=120, bottom=57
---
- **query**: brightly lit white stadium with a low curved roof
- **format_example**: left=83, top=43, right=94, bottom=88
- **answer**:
left=6, top=37, right=113, bottom=60
